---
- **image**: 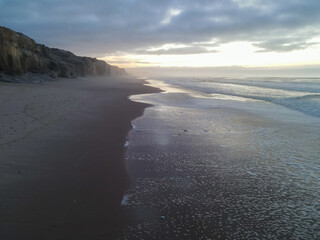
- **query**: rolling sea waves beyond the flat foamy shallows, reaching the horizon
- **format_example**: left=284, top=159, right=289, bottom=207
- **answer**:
left=160, top=78, right=320, bottom=117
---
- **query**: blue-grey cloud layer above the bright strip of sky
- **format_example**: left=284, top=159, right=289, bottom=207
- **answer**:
left=0, top=0, right=320, bottom=56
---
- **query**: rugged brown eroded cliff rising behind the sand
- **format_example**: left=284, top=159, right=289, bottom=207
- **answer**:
left=0, top=27, right=126, bottom=78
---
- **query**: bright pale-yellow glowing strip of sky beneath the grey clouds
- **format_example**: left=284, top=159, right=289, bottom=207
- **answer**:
left=103, top=42, right=320, bottom=68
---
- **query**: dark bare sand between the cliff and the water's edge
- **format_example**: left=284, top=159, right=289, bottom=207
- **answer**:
left=0, top=77, right=157, bottom=239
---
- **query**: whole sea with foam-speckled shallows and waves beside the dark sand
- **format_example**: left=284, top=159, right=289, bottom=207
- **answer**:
left=123, top=77, right=320, bottom=239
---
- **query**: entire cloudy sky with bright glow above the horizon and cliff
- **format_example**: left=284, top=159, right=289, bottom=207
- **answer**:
left=0, top=0, right=320, bottom=68
